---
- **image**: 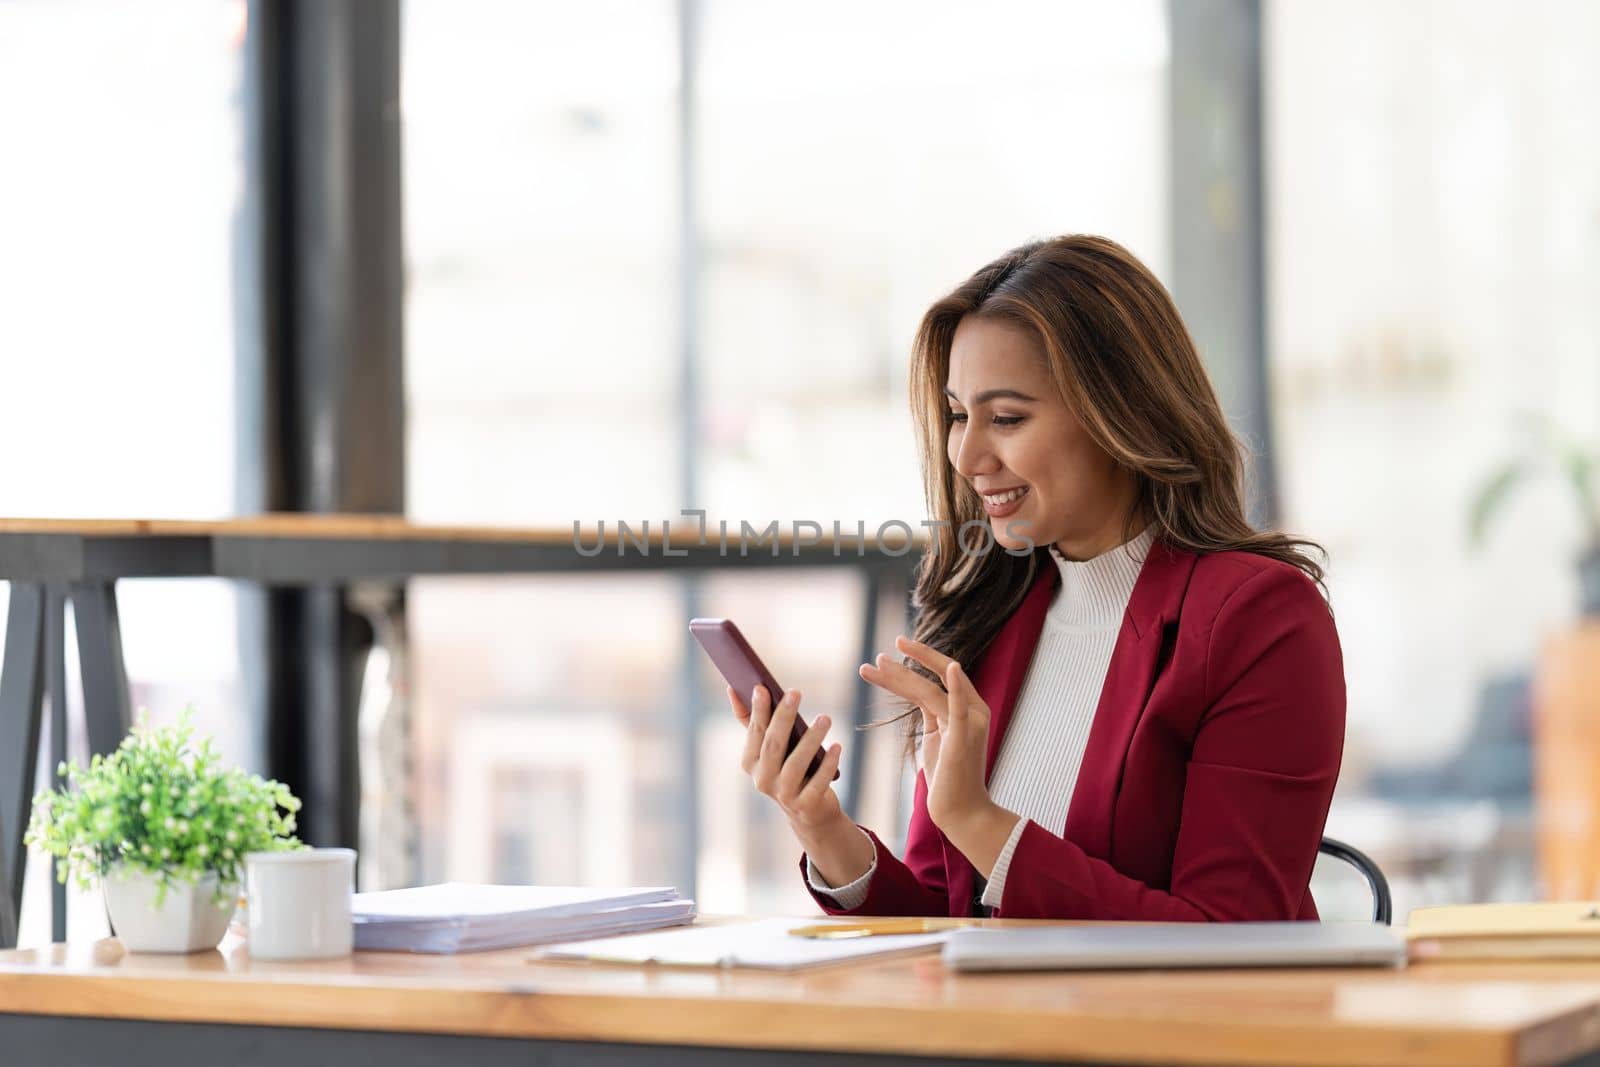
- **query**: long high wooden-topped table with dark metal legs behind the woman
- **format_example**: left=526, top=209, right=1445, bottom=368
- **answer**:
left=0, top=515, right=928, bottom=949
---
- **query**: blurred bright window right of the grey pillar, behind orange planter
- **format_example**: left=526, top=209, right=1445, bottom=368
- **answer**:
left=1266, top=2, right=1600, bottom=915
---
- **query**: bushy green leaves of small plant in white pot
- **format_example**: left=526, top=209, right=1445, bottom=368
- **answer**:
left=24, top=709, right=302, bottom=904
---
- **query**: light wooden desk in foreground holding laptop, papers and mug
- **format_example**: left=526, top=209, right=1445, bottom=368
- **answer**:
left=0, top=939, right=1600, bottom=1067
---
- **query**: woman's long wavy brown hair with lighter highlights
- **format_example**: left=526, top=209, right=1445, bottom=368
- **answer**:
left=874, top=235, right=1326, bottom=752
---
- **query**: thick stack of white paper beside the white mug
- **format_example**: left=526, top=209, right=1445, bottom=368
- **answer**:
left=352, top=881, right=694, bottom=952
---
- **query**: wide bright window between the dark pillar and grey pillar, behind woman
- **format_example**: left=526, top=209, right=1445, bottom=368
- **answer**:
left=403, top=0, right=1168, bottom=912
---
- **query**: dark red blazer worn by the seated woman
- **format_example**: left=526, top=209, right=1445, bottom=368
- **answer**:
left=800, top=542, right=1344, bottom=921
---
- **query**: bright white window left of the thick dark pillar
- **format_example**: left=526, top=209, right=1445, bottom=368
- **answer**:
left=0, top=0, right=246, bottom=944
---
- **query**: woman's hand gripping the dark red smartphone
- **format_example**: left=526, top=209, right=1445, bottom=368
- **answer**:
left=728, top=685, right=874, bottom=886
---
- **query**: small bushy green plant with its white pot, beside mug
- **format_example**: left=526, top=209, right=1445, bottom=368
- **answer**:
left=26, top=709, right=301, bottom=952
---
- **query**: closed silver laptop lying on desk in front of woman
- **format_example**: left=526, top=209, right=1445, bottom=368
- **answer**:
left=944, top=921, right=1406, bottom=971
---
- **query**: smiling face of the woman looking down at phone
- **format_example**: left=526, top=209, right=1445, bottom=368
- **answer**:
left=944, top=315, right=1138, bottom=560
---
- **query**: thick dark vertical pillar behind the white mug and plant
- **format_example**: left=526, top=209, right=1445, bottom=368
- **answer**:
left=235, top=0, right=405, bottom=846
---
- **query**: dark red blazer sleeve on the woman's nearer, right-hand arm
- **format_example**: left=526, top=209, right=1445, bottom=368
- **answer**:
left=1000, top=568, right=1344, bottom=921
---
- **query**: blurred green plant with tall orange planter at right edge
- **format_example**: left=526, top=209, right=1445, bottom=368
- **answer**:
left=1469, top=418, right=1600, bottom=901
